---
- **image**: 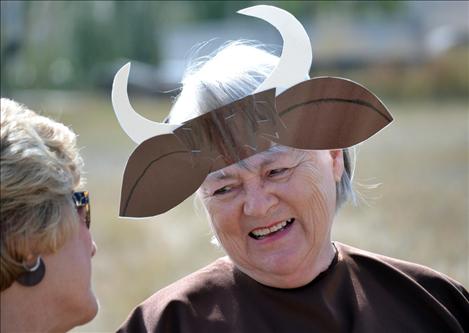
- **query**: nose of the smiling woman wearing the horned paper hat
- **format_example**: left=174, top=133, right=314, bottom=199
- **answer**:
left=243, top=184, right=278, bottom=217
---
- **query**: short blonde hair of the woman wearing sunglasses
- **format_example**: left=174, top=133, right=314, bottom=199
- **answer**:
left=0, top=98, right=83, bottom=291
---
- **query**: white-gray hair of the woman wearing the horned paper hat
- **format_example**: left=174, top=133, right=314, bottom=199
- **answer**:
left=167, top=41, right=355, bottom=209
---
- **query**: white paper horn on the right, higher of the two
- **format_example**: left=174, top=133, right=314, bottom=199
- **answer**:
left=238, top=5, right=313, bottom=95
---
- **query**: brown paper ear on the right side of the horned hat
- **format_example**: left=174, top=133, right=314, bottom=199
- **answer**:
left=276, top=77, right=393, bottom=149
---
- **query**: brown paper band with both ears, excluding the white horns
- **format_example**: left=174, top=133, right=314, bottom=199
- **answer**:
left=120, top=77, right=392, bottom=217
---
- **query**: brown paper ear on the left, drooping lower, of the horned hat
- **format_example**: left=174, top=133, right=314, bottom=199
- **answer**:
left=119, top=134, right=210, bottom=217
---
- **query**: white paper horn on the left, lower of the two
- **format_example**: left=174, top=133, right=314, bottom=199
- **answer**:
left=112, top=62, right=180, bottom=144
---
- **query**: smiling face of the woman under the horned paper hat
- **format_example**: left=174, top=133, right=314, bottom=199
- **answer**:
left=199, top=147, right=343, bottom=288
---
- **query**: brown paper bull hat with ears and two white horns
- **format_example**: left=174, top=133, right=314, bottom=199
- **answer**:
left=112, top=5, right=392, bottom=218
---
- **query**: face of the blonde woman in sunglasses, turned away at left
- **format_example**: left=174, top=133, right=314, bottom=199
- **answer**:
left=40, top=209, right=98, bottom=329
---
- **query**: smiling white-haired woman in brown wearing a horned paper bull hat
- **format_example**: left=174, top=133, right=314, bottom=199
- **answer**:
left=113, top=6, right=469, bottom=333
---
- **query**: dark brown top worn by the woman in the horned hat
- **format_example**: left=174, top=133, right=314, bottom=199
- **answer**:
left=118, top=242, right=469, bottom=333
